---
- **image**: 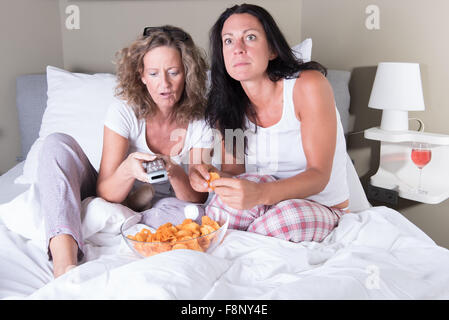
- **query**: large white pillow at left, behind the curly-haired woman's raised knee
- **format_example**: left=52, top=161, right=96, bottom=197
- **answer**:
left=15, top=66, right=116, bottom=183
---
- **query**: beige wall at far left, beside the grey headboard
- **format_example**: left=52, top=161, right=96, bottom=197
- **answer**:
left=0, top=0, right=63, bottom=174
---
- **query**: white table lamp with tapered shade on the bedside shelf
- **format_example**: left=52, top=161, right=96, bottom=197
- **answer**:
left=368, top=62, right=425, bottom=131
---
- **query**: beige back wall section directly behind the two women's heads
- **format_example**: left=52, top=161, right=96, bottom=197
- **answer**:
left=56, top=0, right=302, bottom=72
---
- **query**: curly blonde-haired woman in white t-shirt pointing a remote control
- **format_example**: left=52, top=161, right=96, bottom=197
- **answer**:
left=40, top=26, right=212, bottom=277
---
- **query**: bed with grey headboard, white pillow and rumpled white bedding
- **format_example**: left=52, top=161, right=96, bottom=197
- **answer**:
left=0, top=67, right=449, bottom=300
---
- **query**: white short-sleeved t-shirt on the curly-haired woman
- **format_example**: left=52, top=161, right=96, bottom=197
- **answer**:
left=104, top=98, right=213, bottom=198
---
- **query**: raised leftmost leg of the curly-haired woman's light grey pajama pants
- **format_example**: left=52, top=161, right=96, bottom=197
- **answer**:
left=38, top=133, right=98, bottom=260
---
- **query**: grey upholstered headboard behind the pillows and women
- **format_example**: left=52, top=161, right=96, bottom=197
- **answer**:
left=16, top=70, right=351, bottom=160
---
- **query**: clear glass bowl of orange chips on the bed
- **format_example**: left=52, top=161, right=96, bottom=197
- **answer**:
left=120, top=205, right=229, bottom=258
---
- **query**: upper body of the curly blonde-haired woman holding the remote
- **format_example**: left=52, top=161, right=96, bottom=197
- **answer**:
left=97, top=26, right=211, bottom=202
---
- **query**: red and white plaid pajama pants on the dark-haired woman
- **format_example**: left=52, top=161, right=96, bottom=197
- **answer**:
left=206, top=173, right=345, bottom=242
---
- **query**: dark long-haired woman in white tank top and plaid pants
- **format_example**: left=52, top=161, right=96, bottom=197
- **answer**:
left=190, top=4, right=349, bottom=242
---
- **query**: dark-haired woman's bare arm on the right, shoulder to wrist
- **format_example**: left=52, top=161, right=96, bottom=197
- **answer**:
left=263, top=71, right=337, bottom=204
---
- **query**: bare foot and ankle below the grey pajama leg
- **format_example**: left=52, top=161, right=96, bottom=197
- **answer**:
left=50, top=234, right=78, bottom=278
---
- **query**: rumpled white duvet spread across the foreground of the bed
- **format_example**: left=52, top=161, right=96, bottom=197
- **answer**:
left=0, top=164, right=449, bottom=299
